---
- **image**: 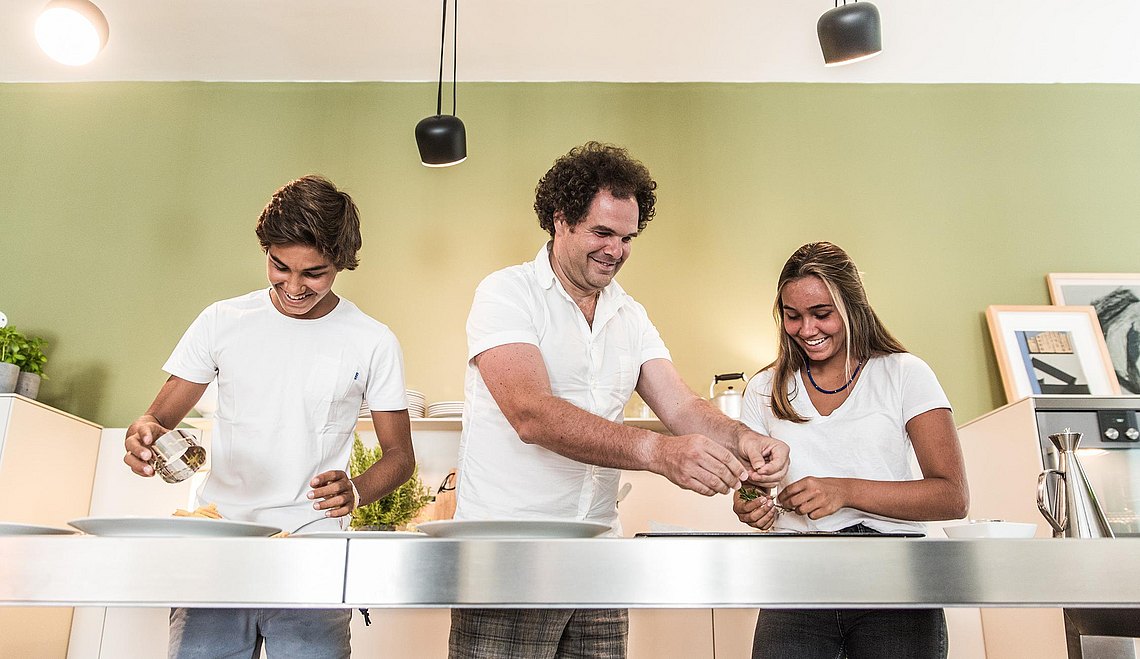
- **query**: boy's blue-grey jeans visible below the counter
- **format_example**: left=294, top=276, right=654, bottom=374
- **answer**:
left=169, top=609, right=352, bottom=659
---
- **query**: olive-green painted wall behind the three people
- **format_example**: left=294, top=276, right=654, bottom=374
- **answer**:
left=0, top=83, right=1140, bottom=425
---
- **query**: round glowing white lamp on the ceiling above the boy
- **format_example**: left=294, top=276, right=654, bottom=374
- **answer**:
left=35, top=0, right=111, bottom=66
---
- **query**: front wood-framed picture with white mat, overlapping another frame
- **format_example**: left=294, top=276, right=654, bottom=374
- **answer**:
left=986, top=306, right=1121, bottom=402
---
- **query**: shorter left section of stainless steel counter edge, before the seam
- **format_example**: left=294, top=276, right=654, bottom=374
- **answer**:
left=0, top=536, right=348, bottom=608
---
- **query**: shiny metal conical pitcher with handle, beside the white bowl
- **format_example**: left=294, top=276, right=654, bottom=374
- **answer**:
left=1037, top=428, right=1116, bottom=538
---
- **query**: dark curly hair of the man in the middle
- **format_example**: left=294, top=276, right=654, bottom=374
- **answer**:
left=535, top=141, right=657, bottom=237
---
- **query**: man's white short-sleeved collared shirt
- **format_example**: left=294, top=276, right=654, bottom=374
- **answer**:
left=455, top=241, right=669, bottom=532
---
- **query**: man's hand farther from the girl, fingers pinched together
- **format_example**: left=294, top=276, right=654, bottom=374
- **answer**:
left=650, top=434, right=748, bottom=496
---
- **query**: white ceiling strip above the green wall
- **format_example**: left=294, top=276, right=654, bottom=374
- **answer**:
left=0, top=0, right=1140, bottom=83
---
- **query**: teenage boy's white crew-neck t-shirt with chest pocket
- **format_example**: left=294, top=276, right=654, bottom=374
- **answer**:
left=163, top=288, right=407, bottom=531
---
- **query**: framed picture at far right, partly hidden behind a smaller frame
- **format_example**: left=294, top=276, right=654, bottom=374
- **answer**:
left=1045, top=272, right=1140, bottom=393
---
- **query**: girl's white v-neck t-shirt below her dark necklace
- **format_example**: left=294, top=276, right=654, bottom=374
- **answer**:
left=740, top=352, right=950, bottom=532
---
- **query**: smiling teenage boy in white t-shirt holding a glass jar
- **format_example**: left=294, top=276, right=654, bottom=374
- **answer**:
left=124, top=176, right=415, bottom=659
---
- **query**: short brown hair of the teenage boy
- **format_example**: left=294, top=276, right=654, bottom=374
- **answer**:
left=255, top=174, right=361, bottom=270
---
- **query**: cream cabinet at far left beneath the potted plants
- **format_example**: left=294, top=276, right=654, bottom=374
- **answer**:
left=0, top=393, right=99, bottom=659
